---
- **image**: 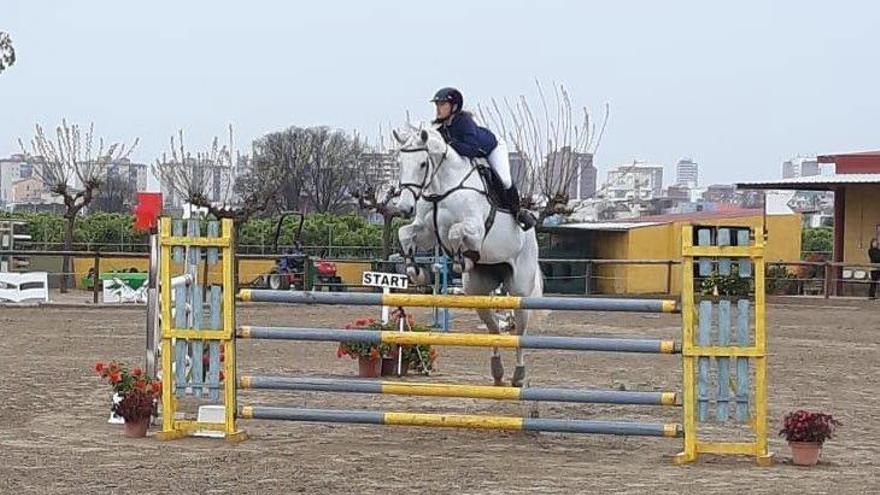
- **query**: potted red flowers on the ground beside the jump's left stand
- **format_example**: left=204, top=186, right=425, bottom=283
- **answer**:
left=94, top=361, right=162, bottom=438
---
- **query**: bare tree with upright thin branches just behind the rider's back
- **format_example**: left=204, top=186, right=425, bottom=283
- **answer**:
left=479, top=81, right=609, bottom=225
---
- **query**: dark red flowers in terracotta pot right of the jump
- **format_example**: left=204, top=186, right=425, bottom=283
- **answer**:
left=779, top=410, right=841, bottom=466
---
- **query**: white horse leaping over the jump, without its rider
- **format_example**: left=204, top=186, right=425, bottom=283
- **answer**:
left=394, top=128, right=543, bottom=387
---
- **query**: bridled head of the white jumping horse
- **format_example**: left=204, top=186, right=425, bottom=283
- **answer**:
left=392, top=128, right=446, bottom=217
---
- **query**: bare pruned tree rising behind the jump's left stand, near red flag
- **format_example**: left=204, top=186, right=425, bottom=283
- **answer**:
left=153, top=126, right=278, bottom=225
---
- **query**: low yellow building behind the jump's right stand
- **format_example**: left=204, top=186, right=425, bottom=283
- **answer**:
left=542, top=209, right=801, bottom=294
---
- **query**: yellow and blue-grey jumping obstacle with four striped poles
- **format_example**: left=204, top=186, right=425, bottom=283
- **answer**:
left=157, top=218, right=772, bottom=465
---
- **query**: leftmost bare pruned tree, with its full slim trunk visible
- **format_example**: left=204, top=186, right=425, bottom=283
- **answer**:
left=19, top=120, right=139, bottom=292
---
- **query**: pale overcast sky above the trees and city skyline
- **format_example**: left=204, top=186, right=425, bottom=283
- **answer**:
left=0, top=0, right=880, bottom=188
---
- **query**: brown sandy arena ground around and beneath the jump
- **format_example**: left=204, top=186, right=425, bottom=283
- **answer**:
left=0, top=300, right=880, bottom=494
